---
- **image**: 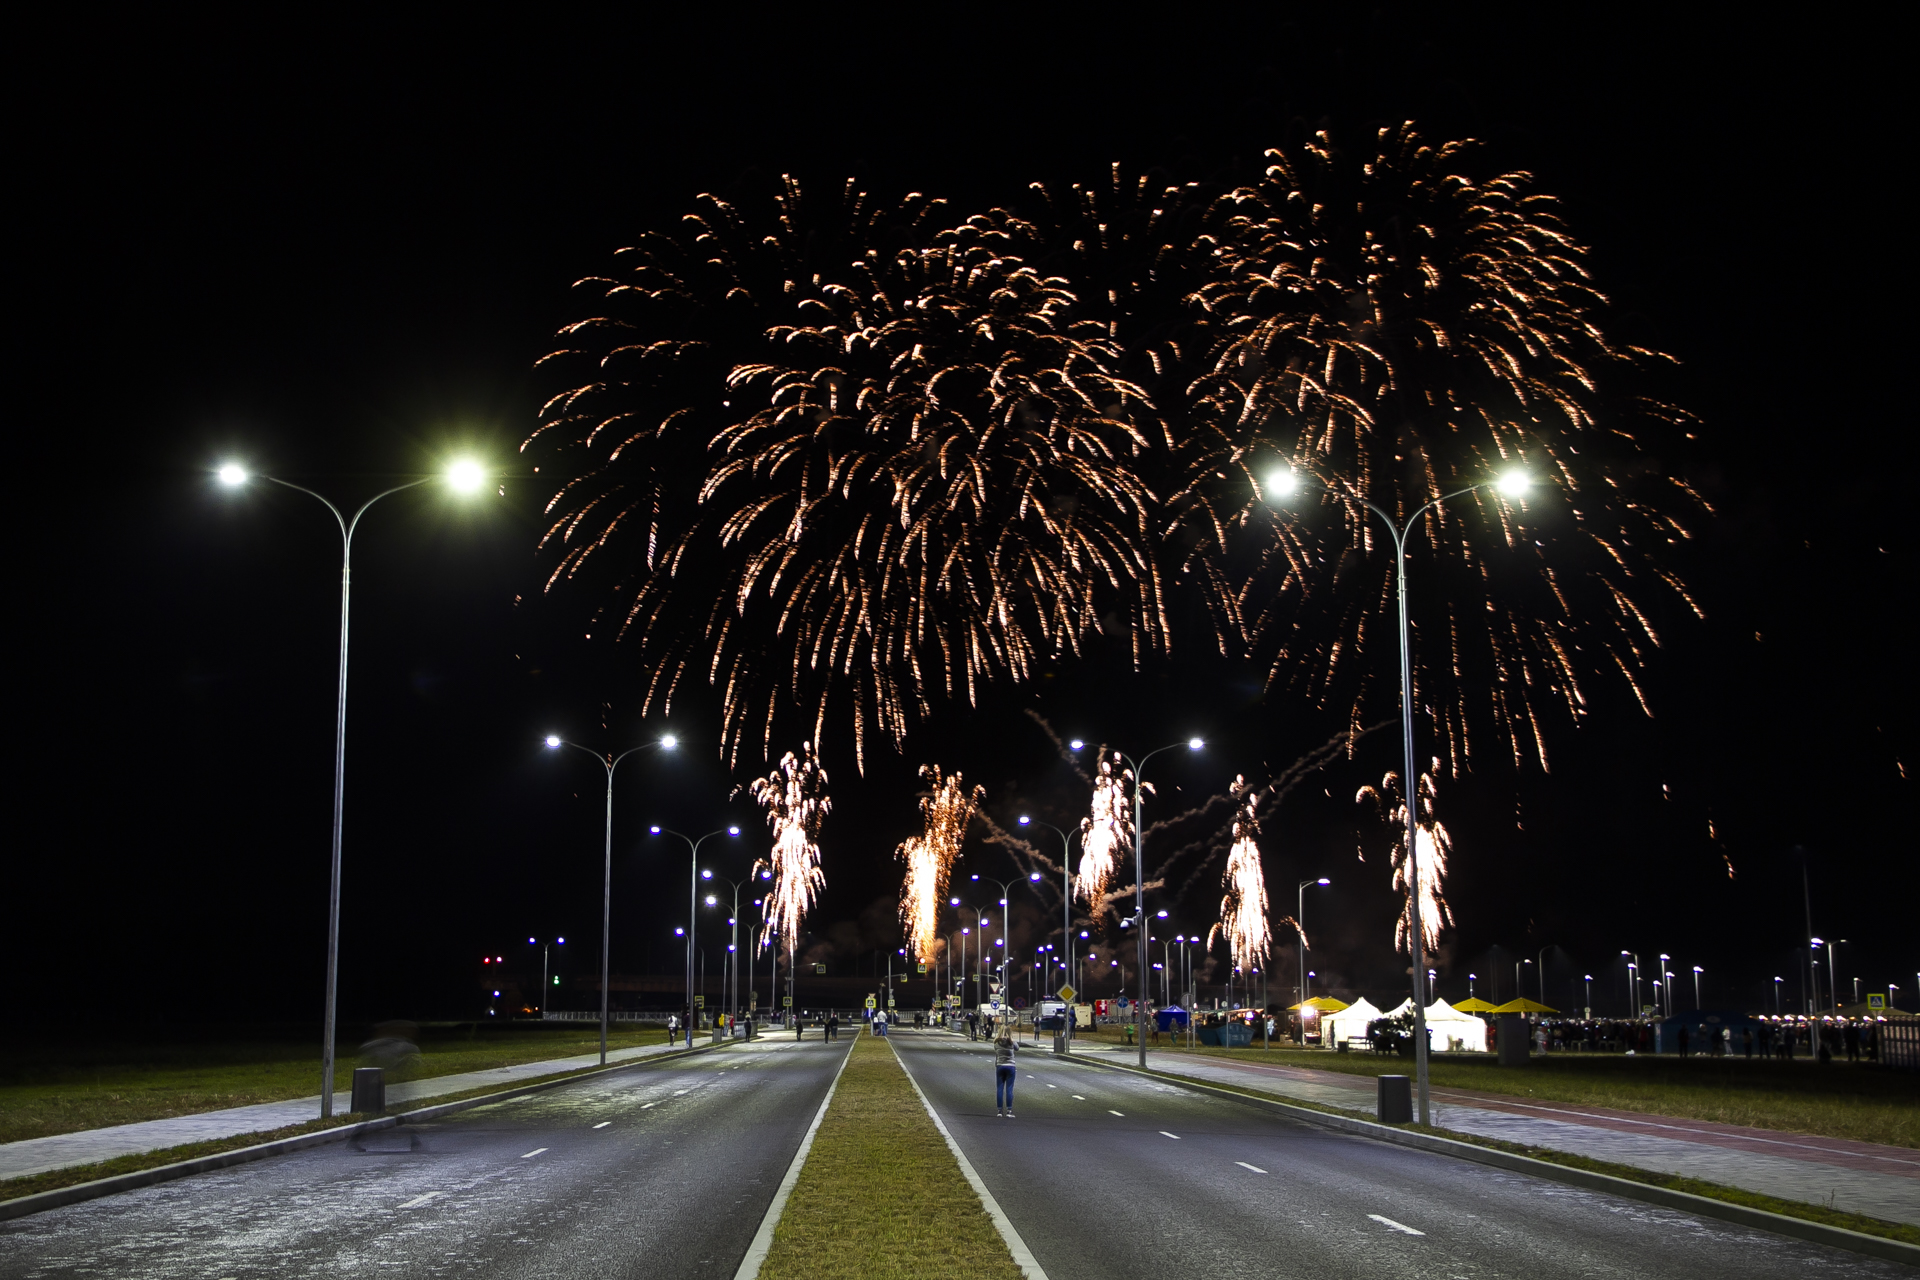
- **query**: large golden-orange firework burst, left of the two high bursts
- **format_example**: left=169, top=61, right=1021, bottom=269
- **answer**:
left=528, top=180, right=1167, bottom=768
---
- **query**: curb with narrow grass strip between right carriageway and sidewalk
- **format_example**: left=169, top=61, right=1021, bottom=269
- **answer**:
left=1077, top=1057, right=1920, bottom=1267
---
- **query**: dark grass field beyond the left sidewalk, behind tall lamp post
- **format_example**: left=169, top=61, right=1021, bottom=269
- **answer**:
left=0, top=1023, right=666, bottom=1142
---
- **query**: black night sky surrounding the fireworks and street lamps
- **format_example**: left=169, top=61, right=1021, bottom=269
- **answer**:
left=4, top=8, right=1920, bottom=1025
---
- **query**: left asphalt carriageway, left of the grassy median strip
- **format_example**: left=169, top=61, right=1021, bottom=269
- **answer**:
left=0, top=1032, right=851, bottom=1280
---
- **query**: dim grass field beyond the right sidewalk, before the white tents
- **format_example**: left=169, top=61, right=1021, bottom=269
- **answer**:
left=1075, top=1032, right=1920, bottom=1148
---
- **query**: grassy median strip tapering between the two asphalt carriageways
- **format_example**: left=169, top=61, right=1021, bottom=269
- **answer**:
left=760, top=1036, right=1020, bottom=1280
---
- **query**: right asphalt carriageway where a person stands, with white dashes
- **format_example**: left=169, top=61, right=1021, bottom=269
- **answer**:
left=893, top=1032, right=1914, bottom=1280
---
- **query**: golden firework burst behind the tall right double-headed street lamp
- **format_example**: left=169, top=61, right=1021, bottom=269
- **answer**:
left=1167, top=125, right=1707, bottom=768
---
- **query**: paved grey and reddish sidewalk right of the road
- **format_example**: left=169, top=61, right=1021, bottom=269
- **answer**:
left=1079, top=1046, right=1920, bottom=1226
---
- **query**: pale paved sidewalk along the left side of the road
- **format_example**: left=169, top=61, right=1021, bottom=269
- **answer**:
left=0, top=1044, right=706, bottom=1178
